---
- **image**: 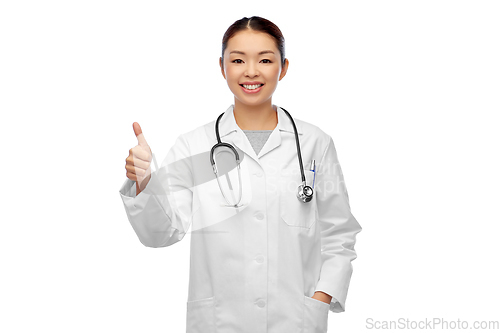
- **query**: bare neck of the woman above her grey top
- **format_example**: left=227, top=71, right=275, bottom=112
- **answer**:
left=233, top=99, right=278, bottom=131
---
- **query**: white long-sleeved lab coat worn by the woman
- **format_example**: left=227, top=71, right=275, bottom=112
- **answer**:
left=120, top=105, right=361, bottom=333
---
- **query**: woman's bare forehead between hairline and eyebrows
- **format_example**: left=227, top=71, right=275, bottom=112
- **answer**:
left=225, top=30, right=278, bottom=54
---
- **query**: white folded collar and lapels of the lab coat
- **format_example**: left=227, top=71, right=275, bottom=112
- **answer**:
left=219, top=104, right=303, bottom=163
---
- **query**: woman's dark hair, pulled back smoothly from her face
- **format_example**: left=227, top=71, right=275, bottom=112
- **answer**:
left=222, top=16, right=285, bottom=66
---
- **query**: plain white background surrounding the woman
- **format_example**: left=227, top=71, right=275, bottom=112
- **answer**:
left=0, top=0, right=500, bottom=333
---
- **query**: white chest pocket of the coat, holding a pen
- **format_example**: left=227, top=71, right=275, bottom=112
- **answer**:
left=279, top=170, right=316, bottom=229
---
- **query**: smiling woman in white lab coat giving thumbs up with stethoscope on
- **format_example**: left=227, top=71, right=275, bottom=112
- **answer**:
left=120, top=16, right=361, bottom=333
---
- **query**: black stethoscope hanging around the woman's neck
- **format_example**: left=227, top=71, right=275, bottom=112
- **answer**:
left=210, top=108, right=314, bottom=208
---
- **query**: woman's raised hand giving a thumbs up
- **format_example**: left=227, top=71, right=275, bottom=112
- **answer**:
left=125, top=122, right=153, bottom=195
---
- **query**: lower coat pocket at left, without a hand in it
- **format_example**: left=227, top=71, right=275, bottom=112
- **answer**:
left=186, top=296, right=215, bottom=333
